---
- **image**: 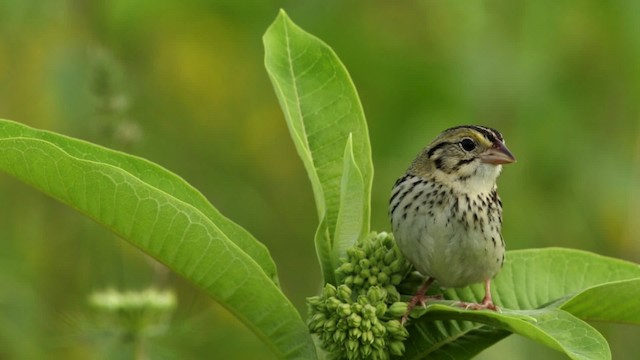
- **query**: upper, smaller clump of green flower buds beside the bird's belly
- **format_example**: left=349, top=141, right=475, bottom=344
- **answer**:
left=336, top=232, right=410, bottom=302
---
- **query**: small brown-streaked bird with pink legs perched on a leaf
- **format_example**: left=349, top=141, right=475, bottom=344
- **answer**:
left=389, top=125, right=516, bottom=324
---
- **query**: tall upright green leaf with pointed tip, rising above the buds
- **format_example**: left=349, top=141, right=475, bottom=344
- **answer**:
left=263, top=11, right=373, bottom=281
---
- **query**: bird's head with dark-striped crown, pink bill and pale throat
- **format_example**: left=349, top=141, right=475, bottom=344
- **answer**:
left=409, top=125, right=516, bottom=193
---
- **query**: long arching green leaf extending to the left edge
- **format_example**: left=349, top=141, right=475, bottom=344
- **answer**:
left=0, top=120, right=315, bottom=359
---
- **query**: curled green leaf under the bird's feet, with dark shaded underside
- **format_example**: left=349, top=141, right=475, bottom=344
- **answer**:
left=406, top=248, right=640, bottom=359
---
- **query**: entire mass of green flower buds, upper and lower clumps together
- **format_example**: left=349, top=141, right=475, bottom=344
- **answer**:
left=307, top=233, right=409, bottom=360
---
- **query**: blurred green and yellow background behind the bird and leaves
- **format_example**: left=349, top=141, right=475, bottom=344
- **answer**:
left=0, top=0, right=640, bottom=359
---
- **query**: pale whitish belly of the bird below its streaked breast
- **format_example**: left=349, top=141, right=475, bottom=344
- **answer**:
left=391, top=181, right=505, bottom=287
